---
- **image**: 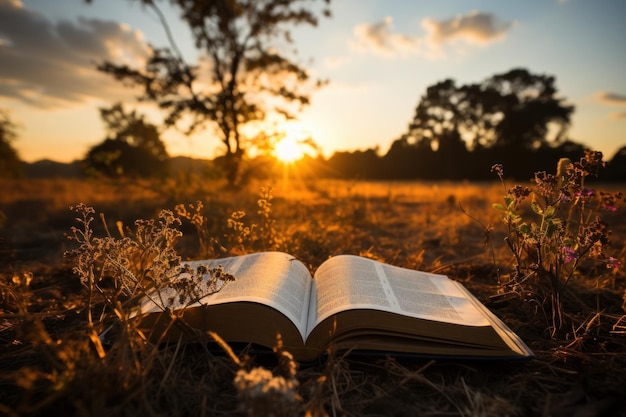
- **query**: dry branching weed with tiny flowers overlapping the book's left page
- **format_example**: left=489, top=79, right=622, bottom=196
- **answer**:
left=68, top=204, right=233, bottom=331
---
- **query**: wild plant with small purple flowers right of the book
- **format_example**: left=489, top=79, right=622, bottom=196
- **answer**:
left=493, top=151, right=622, bottom=335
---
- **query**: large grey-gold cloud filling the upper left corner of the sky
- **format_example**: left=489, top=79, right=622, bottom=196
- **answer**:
left=0, top=0, right=148, bottom=108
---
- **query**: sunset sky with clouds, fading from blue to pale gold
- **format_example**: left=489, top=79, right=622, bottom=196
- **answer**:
left=0, top=0, right=626, bottom=162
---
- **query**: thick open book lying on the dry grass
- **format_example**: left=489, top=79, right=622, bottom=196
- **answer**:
left=141, top=252, right=533, bottom=361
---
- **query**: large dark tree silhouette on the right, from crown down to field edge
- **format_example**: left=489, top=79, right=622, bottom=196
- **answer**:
left=394, top=69, right=578, bottom=179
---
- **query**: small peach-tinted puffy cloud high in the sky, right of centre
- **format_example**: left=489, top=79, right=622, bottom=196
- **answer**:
left=350, top=11, right=515, bottom=57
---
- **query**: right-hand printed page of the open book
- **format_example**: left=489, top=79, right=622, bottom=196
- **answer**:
left=307, top=255, right=489, bottom=332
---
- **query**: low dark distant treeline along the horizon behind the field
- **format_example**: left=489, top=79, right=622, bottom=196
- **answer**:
left=22, top=140, right=626, bottom=181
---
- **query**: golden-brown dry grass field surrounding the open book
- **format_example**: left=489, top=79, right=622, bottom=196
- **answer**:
left=0, top=174, right=626, bottom=416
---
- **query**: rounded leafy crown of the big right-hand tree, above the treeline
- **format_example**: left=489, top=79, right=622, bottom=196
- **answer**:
left=407, top=69, right=574, bottom=150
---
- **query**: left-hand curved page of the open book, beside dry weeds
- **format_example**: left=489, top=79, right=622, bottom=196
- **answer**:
left=142, top=252, right=312, bottom=340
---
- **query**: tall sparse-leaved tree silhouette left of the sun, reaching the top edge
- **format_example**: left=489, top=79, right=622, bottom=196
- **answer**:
left=99, top=0, right=330, bottom=184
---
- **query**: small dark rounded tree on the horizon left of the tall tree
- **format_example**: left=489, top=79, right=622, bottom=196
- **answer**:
left=85, top=103, right=169, bottom=177
